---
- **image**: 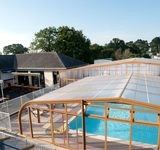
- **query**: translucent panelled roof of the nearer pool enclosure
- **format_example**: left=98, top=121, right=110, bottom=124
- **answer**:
left=34, top=74, right=160, bottom=108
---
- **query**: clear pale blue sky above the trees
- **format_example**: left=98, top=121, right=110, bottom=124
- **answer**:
left=0, top=0, right=160, bottom=52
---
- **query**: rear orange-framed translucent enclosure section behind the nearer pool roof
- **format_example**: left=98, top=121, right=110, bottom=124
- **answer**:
left=59, top=58, right=160, bottom=87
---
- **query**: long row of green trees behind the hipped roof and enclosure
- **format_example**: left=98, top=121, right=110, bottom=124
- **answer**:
left=30, top=26, right=155, bottom=63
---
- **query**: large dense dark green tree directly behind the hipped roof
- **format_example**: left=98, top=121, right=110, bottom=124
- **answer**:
left=55, top=26, right=91, bottom=62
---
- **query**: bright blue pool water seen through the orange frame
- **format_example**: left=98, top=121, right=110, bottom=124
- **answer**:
left=70, top=103, right=158, bottom=144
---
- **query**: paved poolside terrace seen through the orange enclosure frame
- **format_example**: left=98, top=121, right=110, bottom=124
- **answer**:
left=6, top=104, right=157, bottom=150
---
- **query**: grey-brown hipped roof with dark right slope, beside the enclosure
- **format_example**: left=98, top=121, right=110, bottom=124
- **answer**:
left=16, top=52, right=87, bottom=69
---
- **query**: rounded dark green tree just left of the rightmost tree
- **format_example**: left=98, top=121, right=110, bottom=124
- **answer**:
left=134, top=39, right=149, bottom=57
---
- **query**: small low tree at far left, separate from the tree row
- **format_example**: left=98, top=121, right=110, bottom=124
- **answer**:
left=3, top=44, right=28, bottom=55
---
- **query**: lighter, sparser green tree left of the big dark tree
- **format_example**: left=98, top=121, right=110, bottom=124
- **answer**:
left=30, top=27, right=57, bottom=52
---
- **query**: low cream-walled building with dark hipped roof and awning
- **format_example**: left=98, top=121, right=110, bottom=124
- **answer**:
left=0, top=52, right=87, bottom=87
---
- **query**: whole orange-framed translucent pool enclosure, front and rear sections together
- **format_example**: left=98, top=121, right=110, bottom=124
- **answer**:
left=2, top=58, right=160, bottom=150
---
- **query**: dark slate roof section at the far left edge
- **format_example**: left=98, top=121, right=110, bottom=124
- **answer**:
left=0, top=55, right=15, bottom=70
